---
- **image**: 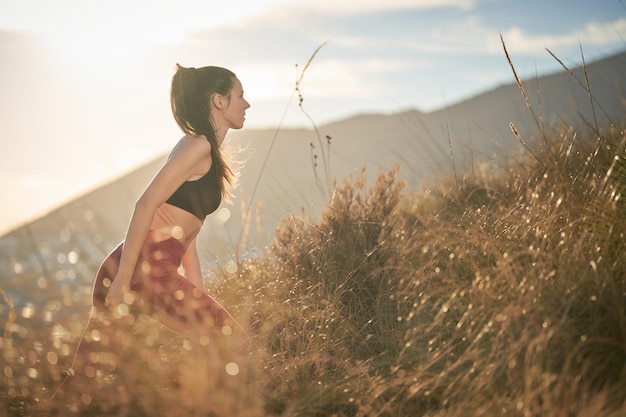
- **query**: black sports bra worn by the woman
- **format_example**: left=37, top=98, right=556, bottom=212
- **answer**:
left=166, top=164, right=222, bottom=221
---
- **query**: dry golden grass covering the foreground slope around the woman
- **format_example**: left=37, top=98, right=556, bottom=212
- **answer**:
left=0, top=118, right=626, bottom=417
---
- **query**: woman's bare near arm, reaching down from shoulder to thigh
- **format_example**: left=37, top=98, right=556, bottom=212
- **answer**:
left=106, top=137, right=211, bottom=306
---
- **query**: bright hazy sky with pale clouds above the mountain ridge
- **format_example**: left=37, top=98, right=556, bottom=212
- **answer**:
left=0, top=0, right=626, bottom=233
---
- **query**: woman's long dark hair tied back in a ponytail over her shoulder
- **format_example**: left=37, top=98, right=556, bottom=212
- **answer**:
left=170, top=64, right=236, bottom=197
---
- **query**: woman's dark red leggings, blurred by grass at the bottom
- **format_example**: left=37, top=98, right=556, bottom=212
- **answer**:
left=54, top=232, right=248, bottom=415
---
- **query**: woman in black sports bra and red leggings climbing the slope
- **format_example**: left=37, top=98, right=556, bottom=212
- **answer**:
left=50, top=65, right=250, bottom=408
